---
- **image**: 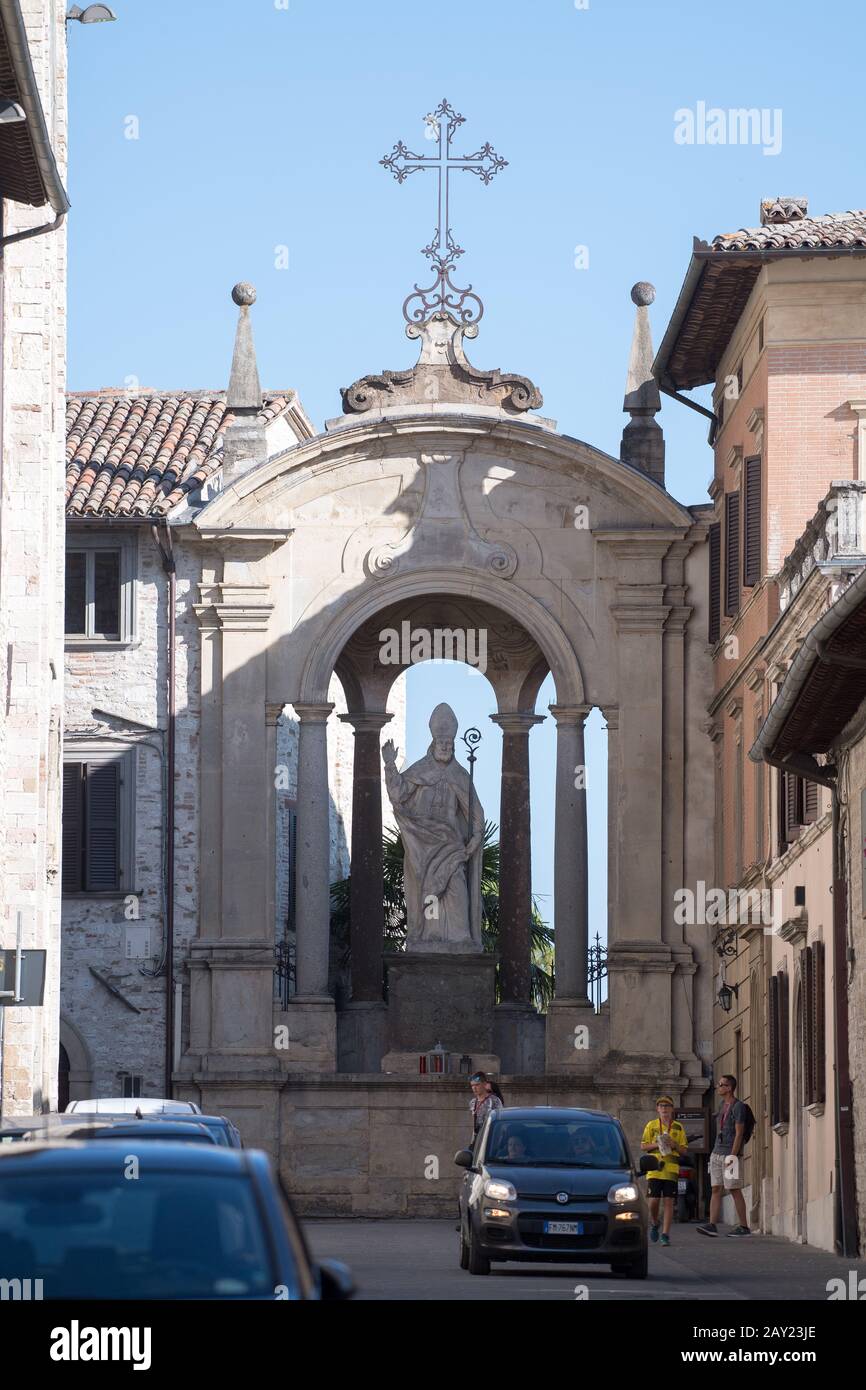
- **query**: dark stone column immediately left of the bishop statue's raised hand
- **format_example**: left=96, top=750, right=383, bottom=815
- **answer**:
left=339, top=712, right=393, bottom=1004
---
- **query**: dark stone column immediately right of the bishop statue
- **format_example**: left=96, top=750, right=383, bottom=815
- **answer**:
left=491, top=713, right=544, bottom=1008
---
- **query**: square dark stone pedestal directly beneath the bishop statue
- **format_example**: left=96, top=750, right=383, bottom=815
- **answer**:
left=385, top=951, right=496, bottom=1055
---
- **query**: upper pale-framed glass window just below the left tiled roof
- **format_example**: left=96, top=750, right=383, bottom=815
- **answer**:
left=64, top=534, right=135, bottom=645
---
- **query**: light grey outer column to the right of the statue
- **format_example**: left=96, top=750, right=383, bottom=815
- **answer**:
left=550, top=705, right=591, bottom=1006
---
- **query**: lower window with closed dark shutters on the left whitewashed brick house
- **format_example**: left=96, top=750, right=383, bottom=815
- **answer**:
left=63, top=749, right=135, bottom=894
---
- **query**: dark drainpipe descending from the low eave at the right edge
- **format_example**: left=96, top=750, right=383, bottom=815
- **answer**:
left=762, top=748, right=859, bottom=1259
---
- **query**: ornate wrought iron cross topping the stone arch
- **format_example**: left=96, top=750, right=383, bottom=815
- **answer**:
left=379, top=100, right=507, bottom=324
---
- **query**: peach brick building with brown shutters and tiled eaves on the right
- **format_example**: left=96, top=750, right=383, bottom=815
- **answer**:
left=655, top=199, right=866, bottom=1245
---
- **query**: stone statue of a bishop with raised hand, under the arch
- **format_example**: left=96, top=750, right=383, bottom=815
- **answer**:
left=382, top=705, right=484, bottom=954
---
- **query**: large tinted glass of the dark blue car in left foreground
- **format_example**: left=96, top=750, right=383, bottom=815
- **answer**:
left=0, top=1161, right=287, bottom=1298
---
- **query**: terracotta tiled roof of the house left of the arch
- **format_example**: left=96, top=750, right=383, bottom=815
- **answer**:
left=67, top=389, right=296, bottom=517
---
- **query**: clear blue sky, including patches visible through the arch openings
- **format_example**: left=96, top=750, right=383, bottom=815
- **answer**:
left=68, top=0, right=866, bottom=934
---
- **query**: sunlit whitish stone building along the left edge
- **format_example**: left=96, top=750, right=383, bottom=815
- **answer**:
left=0, top=0, right=70, bottom=1113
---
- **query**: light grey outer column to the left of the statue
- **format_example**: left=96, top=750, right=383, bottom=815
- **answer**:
left=295, top=703, right=334, bottom=1004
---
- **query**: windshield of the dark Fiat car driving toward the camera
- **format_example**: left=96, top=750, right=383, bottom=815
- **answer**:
left=484, top=1116, right=628, bottom=1168
